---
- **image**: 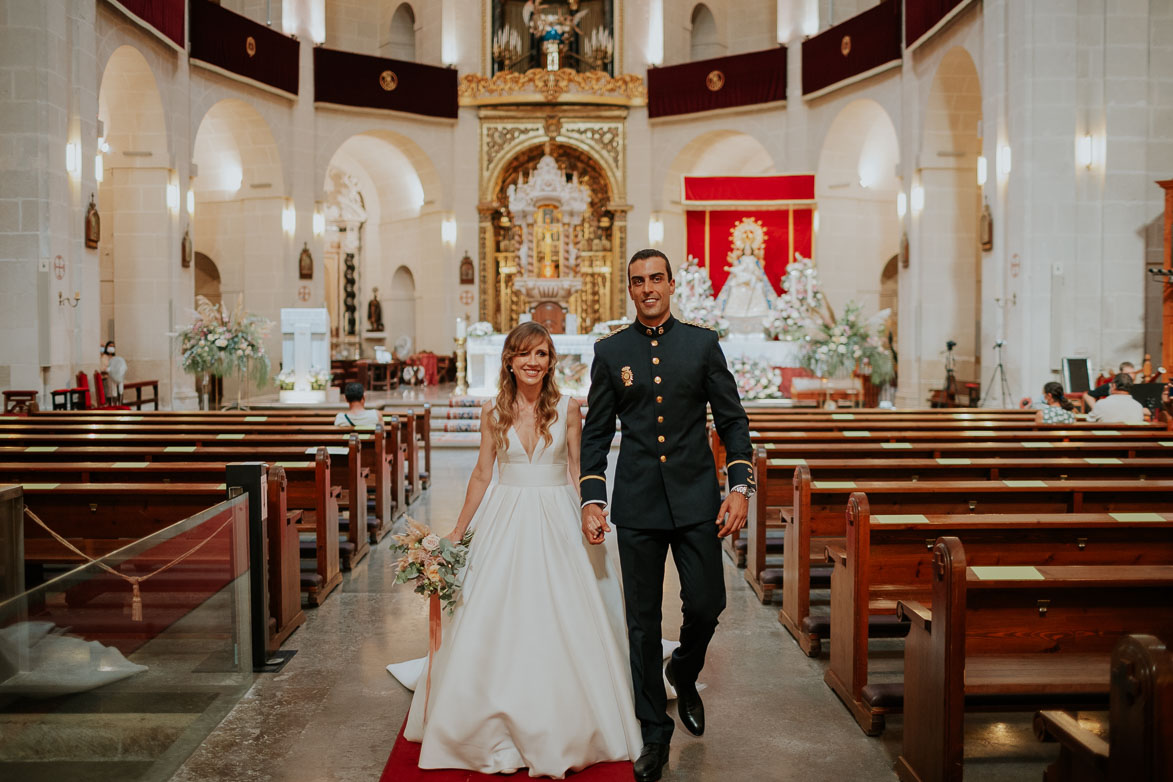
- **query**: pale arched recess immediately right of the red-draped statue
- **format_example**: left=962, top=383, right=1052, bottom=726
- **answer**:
left=815, top=98, right=901, bottom=313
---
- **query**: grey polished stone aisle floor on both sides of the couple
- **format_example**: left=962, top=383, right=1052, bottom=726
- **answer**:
left=172, top=449, right=1074, bottom=782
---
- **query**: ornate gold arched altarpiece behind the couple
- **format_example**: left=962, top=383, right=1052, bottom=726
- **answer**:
left=479, top=106, right=631, bottom=333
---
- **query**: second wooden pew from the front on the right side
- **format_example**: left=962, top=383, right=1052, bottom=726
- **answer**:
left=896, top=537, right=1173, bottom=782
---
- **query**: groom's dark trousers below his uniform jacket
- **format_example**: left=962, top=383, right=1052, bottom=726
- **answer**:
left=618, top=522, right=725, bottom=743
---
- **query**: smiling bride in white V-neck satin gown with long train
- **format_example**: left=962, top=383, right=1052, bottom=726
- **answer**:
left=388, top=322, right=643, bottom=777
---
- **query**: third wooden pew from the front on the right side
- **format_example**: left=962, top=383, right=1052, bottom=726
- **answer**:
left=825, top=492, right=1173, bottom=735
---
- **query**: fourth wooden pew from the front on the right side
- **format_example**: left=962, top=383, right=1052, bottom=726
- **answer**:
left=778, top=464, right=1173, bottom=657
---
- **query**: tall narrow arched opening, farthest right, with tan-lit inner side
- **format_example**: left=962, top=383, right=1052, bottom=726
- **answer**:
left=906, top=46, right=980, bottom=397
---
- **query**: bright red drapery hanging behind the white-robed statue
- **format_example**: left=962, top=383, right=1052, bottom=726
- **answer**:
left=684, top=175, right=815, bottom=293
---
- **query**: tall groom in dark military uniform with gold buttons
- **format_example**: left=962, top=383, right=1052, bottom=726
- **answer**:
left=579, top=250, right=754, bottom=782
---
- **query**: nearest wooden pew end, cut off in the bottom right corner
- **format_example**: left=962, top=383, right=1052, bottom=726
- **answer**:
left=1035, top=634, right=1173, bottom=782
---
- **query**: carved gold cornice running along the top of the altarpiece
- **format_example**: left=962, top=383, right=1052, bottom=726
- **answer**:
left=459, top=68, right=647, bottom=106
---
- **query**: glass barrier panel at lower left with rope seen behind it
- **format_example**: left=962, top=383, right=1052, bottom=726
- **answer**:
left=0, top=496, right=253, bottom=782
